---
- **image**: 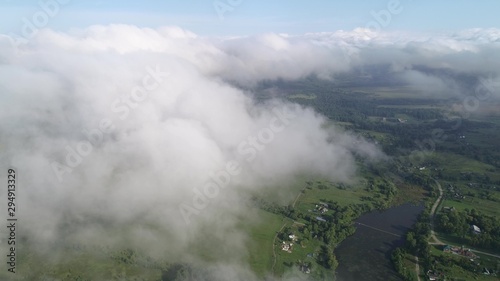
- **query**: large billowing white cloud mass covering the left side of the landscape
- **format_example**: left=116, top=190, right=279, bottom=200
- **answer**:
left=0, top=25, right=381, bottom=278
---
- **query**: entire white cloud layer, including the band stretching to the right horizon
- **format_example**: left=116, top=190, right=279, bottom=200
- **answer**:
left=0, top=25, right=500, bottom=280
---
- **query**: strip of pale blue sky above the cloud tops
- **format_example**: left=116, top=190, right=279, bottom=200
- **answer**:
left=0, top=0, right=500, bottom=36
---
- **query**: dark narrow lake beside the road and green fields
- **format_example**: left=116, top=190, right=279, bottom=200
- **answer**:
left=335, top=204, right=424, bottom=281
